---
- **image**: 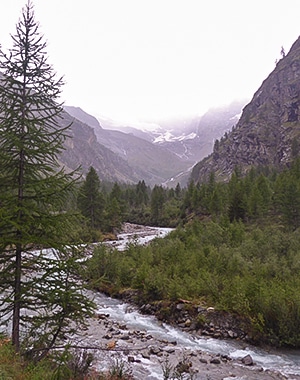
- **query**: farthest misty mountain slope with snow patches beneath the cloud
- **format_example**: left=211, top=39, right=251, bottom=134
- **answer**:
left=95, top=100, right=247, bottom=164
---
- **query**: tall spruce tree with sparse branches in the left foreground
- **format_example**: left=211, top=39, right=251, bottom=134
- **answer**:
left=0, top=1, right=92, bottom=359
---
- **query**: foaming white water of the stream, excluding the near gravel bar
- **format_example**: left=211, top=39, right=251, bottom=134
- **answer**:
left=86, top=228, right=300, bottom=378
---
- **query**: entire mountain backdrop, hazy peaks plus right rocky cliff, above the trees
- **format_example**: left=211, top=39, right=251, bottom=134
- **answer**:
left=61, top=34, right=300, bottom=187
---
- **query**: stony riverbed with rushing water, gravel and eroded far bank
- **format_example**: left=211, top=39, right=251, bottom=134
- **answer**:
left=77, top=224, right=300, bottom=380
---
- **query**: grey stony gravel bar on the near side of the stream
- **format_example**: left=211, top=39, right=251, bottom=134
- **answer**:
left=78, top=306, right=300, bottom=380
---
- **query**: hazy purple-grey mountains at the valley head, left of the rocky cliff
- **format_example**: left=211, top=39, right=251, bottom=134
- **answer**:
left=60, top=101, right=245, bottom=186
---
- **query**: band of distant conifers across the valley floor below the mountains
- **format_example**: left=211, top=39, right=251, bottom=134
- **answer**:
left=77, top=159, right=300, bottom=240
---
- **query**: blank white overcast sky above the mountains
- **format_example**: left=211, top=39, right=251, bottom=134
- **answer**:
left=0, top=0, right=300, bottom=121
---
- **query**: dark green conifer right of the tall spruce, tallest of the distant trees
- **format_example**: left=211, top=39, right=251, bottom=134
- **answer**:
left=78, top=167, right=104, bottom=229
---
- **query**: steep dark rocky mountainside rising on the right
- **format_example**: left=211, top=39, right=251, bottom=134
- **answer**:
left=191, top=38, right=300, bottom=181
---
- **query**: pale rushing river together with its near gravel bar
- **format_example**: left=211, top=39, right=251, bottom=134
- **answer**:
left=76, top=228, right=300, bottom=380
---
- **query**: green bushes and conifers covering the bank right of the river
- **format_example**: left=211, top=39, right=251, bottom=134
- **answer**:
left=82, top=161, right=300, bottom=347
